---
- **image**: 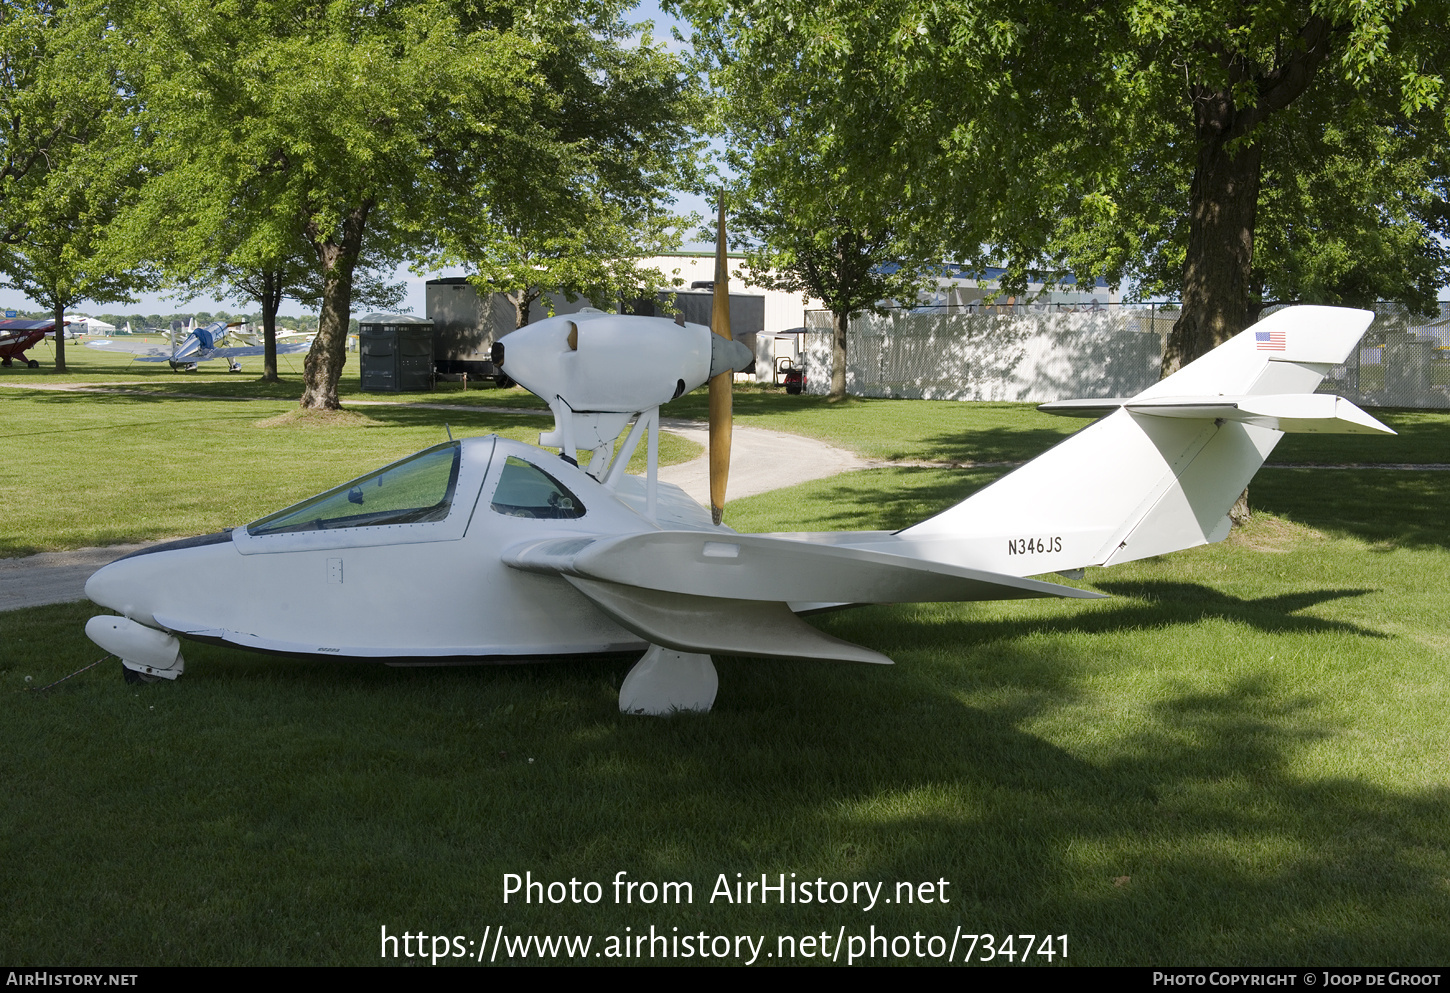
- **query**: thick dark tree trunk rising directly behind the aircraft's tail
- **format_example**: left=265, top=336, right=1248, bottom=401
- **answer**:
left=1163, top=118, right=1260, bottom=377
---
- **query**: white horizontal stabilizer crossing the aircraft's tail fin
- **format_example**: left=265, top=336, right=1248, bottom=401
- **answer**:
left=1038, top=393, right=1395, bottom=435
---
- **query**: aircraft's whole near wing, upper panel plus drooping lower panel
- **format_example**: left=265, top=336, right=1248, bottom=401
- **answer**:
left=503, top=531, right=1102, bottom=662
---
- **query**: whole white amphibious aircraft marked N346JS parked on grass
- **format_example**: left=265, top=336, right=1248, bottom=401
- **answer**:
left=86, top=231, right=1393, bottom=713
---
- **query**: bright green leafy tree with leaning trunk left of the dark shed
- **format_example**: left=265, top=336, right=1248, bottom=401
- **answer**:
left=124, top=0, right=696, bottom=407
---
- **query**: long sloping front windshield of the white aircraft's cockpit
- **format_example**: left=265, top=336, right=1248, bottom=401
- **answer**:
left=247, top=442, right=461, bottom=535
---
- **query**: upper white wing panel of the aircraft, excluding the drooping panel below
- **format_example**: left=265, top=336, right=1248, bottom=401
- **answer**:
left=503, top=531, right=1102, bottom=603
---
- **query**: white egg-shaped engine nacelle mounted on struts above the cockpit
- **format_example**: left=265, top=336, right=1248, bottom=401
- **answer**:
left=493, top=312, right=755, bottom=413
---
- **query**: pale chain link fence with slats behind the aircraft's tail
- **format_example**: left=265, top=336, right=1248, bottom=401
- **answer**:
left=802, top=303, right=1450, bottom=409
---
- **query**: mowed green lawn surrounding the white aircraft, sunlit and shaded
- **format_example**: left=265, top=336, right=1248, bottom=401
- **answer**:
left=0, top=384, right=1450, bottom=965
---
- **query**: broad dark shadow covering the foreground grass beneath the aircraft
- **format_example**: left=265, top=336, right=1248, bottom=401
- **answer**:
left=11, top=591, right=1450, bottom=965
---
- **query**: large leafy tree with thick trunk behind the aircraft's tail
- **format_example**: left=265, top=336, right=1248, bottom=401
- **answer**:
left=689, top=0, right=1450, bottom=374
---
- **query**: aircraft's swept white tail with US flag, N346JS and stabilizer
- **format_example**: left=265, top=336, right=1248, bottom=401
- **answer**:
left=898, top=307, right=1395, bottom=576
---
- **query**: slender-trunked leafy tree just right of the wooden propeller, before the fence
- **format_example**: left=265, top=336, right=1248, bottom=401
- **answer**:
left=683, top=0, right=957, bottom=399
